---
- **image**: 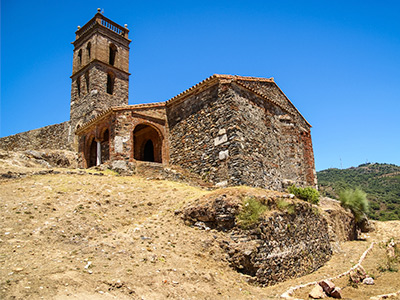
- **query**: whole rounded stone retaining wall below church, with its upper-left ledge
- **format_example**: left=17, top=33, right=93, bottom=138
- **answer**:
left=183, top=192, right=332, bottom=286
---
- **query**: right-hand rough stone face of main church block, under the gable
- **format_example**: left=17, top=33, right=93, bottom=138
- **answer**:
left=230, top=82, right=314, bottom=190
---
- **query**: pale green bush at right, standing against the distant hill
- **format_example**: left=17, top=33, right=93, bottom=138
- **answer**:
left=339, top=189, right=368, bottom=223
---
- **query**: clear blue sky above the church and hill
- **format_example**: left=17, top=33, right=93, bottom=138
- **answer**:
left=0, top=0, right=400, bottom=170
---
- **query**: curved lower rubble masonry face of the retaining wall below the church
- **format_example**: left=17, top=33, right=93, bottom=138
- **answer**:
left=225, top=204, right=332, bottom=285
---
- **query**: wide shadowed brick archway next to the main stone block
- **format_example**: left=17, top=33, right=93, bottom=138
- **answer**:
left=133, top=124, right=162, bottom=163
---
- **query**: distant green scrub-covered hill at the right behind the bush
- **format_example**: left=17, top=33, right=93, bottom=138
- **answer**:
left=317, top=163, right=400, bottom=221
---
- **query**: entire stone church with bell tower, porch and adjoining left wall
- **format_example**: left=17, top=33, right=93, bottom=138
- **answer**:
left=0, top=12, right=316, bottom=190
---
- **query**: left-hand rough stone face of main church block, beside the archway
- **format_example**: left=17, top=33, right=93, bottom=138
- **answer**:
left=167, top=84, right=239, bottom=184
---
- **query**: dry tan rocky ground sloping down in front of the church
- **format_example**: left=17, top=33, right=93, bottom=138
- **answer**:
left=0, top=153, right=400, bottom=299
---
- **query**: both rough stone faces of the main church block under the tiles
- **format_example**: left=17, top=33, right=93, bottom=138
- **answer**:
left=167, top=82, right=316, bottom=190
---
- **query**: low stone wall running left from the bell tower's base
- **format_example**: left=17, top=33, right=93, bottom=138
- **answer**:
left=0, top=121, right=73, bottom=151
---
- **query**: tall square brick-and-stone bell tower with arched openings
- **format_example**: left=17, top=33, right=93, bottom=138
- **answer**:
left=70, top=9, right=131, bottom=134
